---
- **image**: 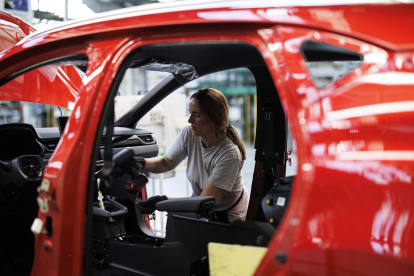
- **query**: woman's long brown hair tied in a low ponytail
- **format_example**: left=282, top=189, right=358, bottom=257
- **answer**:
left=190, top=88, right=246, bottom=160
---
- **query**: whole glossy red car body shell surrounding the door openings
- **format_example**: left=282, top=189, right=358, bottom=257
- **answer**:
left=0, top=1, right=414, bottom=275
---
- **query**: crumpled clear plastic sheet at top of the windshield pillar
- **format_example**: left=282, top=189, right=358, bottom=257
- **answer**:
left=130, top=58, right=198, bottom=80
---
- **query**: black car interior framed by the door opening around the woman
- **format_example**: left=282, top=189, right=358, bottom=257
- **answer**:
left=85, top=41, right=292, bottom=275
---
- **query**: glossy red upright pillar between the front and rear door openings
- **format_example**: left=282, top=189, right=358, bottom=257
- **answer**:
left=32, top=39, right=126, bottom=275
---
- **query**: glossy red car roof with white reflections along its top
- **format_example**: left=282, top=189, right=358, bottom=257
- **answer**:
left=0, top=0, right=414, bottom=58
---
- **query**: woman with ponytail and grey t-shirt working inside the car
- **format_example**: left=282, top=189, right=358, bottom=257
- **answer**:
left=140, top=88, right=249, bottom=222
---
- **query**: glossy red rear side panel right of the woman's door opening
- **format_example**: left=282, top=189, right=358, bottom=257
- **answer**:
left=256, top=27, right=414, bottom=275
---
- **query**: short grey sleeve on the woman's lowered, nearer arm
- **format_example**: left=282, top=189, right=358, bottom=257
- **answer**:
left=207, top=148, right=241, bottom=191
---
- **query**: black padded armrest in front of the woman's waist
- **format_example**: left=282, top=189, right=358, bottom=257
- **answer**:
left=155, top=196, right=216, bottom=213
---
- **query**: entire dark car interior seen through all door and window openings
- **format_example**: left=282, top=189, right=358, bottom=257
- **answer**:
left=0, top=38, right=361, bottom=275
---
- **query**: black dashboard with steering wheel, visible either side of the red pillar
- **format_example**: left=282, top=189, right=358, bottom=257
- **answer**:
left=0, top=123, right=158, bottom=216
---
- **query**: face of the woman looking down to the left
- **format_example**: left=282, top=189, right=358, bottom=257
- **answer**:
left=188, top=98, right=213, bottom=138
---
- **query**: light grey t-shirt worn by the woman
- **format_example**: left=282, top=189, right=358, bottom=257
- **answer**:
left=165, top=126, right=249, bottom=221
